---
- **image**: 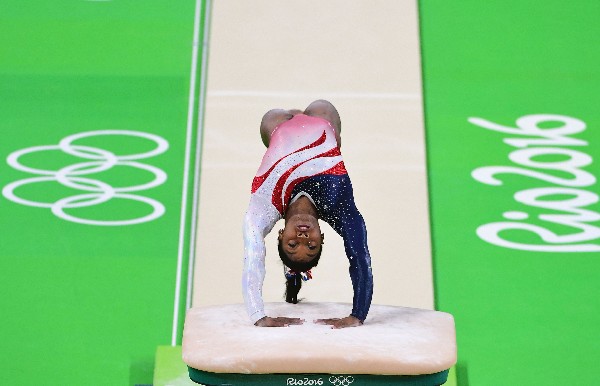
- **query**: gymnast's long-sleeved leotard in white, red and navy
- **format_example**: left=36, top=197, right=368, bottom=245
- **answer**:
left=242, top=114, right=373, bottom=323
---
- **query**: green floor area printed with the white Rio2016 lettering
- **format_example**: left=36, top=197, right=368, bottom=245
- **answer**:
left=420, top=0, right=600, bottom=386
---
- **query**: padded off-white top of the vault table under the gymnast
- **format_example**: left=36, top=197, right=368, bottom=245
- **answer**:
left=183, top=302, right=456, bottom=375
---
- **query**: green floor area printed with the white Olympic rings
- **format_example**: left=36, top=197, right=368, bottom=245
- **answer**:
left=0, top=0, right=204, bottom=386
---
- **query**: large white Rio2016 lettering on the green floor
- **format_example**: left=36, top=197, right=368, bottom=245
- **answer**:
left=469, top=114, right=600, bottom=252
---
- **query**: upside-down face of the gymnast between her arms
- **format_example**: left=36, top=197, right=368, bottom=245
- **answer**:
left=279, top=214, right=323, bottom=263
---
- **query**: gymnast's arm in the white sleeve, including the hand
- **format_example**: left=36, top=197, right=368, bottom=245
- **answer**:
left=242, top=194, right=302, bottom=327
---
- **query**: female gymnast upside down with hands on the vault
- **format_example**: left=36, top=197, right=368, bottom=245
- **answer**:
left=242, top=100, right=373, bottom=328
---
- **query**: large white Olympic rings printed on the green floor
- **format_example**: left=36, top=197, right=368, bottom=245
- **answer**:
left=2, top=130, right=169, bottom=226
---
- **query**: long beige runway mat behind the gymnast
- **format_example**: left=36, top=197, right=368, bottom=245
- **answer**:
left=193, top=0, right=433, bottom=308
